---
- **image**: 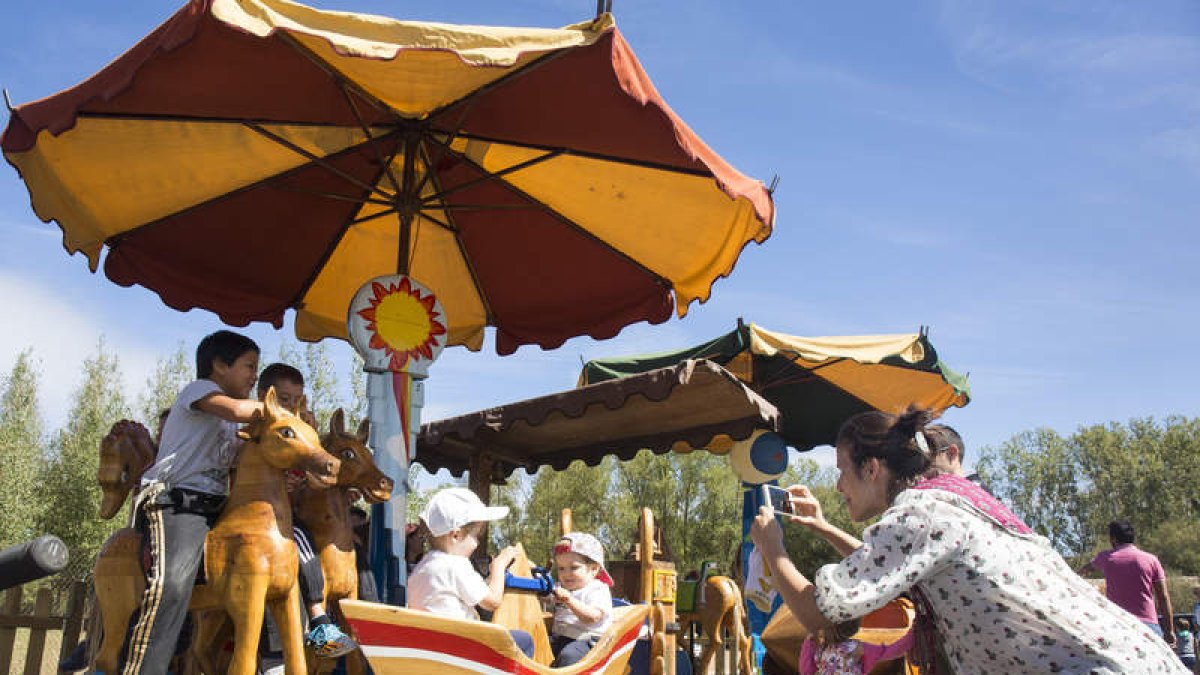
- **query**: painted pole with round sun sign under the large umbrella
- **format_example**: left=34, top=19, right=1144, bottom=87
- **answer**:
left=347, top=274, right=448, bottom=605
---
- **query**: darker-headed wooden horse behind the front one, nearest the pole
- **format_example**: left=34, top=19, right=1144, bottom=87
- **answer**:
left=295, top=408, right=395, bottom=675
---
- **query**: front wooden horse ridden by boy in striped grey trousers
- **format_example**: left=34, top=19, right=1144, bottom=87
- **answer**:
left=95, top=389, right=340, bottom=675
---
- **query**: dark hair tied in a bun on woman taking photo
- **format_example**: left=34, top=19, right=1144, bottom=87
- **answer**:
left=838, top=406, right=934, bottom=496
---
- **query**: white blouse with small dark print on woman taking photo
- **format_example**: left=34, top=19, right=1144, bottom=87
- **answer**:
left=814, top=489, right=1189, bottom=674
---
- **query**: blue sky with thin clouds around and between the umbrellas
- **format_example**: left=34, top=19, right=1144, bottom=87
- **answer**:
left=0, top=0, right=1200, bottom=468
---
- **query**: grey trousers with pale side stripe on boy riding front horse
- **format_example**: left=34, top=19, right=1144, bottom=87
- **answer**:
left=120, top=485, right=220, bottom=675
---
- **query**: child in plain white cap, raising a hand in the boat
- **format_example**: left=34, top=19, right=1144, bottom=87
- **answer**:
left=408, top=488, right=533, bottom=658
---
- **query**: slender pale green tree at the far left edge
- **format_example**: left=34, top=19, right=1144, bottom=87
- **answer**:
left=0, top=350, right=44, bottom=548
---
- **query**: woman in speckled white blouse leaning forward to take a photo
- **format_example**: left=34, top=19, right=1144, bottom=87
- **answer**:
left=750, top=410, right=1188, bottom=674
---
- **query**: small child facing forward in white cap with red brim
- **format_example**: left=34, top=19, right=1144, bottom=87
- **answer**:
left=550, top=532, right=612, bottom=668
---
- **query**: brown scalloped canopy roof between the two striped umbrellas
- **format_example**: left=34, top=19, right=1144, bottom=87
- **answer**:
left=416, top=360, right=779, bottom=477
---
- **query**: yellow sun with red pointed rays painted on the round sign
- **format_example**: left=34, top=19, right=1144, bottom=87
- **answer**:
left=358, top=277, right=446, bottom=371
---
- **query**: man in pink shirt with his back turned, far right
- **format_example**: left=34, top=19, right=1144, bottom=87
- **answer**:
left=1088, top=520, right=1175, bottom=645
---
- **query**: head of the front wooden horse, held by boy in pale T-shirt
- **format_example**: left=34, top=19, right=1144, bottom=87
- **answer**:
left=238, top=387, right=341, bottom=486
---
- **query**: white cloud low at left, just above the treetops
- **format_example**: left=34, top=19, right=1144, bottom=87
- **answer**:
left=0, top=273, right=160, bottom=430
